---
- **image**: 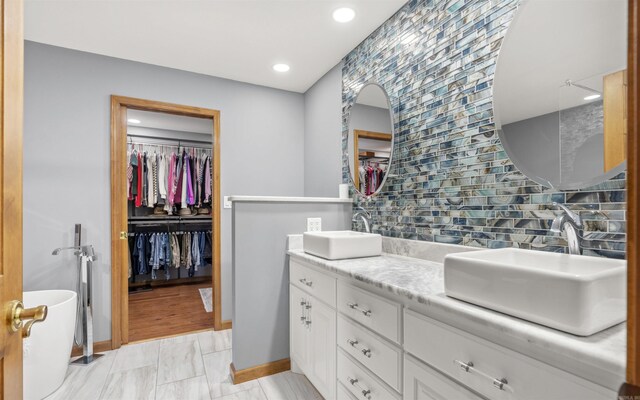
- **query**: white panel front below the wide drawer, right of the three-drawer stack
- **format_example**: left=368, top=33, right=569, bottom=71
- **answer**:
left=404, top=355, right=482, bottom=400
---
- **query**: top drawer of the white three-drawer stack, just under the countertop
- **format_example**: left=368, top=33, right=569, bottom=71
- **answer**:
left=336, top=282, right=402, bottom=343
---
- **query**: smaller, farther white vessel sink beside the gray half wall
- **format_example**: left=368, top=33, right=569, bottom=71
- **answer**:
left=303, top=231, right=382, bottom=260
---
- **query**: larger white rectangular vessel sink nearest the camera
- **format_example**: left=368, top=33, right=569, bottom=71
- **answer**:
left=444, top=248, right=627, bottom=336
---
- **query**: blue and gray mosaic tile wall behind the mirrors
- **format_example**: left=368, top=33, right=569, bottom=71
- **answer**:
left=342, top=0, right=626, bottom=258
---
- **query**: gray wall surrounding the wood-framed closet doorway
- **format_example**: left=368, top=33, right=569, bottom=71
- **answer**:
left=24, top=42, right=304, bottom=341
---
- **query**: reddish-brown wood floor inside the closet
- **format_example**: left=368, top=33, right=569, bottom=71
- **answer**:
left=129, top=283, right=213, bottom=342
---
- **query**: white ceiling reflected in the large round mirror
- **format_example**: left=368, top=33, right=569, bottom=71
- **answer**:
left=493, top=0, right=627, bottom=126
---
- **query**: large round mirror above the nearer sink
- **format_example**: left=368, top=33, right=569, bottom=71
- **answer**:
left=493, top=0, right=627, bottom=190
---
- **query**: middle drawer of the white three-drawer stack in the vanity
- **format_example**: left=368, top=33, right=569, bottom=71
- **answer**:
left=338, top=315, right=402, bottom=392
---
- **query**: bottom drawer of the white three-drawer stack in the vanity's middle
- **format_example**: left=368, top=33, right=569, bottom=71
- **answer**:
left=338, top=349, right=400, bottom=400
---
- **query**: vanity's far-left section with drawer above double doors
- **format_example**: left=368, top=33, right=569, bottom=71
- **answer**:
left=289, top=262, right=336, bottom=399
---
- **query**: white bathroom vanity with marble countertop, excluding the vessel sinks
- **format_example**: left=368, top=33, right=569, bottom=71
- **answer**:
left=288, top=239, right=625, bottom=400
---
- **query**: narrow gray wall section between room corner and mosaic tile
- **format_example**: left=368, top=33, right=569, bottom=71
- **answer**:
left=304, top=62, right=342, bottom=197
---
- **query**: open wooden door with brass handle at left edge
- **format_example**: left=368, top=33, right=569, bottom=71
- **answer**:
left=0, top=0, right=24, bottom=399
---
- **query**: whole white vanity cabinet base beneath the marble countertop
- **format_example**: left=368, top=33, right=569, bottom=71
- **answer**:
left=290, top=259, right=616, bottom=400
